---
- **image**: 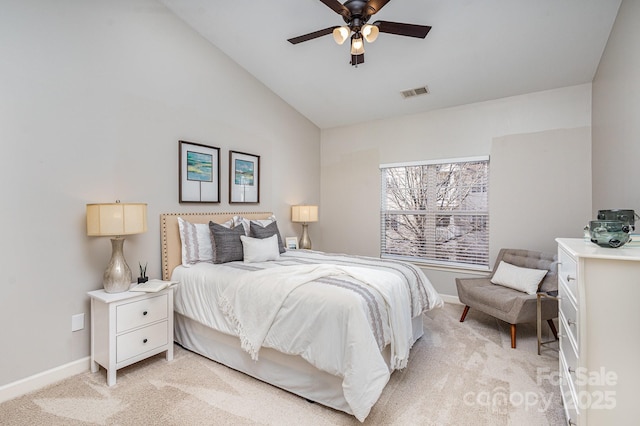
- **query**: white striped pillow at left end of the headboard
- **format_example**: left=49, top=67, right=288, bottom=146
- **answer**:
left=178, top=217, right=234, bottom=268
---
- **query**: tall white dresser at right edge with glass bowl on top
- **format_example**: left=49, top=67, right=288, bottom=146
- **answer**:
left=556, top=238, right=640, bottom=426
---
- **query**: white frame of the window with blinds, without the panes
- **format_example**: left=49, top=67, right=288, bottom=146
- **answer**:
left=379, top=155, right=491, bottom=271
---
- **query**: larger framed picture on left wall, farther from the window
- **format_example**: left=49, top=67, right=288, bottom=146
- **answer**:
left=178, top=141, right=220, bottom=203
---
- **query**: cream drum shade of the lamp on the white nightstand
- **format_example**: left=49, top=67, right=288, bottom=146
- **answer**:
left=87, top=203, right=147, bottom=237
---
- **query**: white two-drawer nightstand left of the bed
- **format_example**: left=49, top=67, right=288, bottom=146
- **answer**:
left=88, top=288, right=173, bottom=386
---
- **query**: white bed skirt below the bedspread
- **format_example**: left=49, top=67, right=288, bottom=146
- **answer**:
left=174, top=312, right=423, bottom=414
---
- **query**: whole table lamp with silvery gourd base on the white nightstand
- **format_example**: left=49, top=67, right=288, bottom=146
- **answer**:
left=87, top=201, right=147, bottom=293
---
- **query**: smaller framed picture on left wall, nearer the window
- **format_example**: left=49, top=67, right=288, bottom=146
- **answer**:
left=229, top=151, right=260, bottom=204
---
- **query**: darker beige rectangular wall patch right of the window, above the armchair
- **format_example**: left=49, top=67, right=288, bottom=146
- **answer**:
left=489, top=126, right=591, bottom=258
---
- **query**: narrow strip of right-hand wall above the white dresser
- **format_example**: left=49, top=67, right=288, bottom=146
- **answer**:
left=593, top=0, right=640, bottom=215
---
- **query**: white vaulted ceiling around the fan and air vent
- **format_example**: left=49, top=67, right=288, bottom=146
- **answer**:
left=161, top=0, right=621, bottom=128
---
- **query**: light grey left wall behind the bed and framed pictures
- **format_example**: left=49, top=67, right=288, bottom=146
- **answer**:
left=0, top=0, right=320, bottom=386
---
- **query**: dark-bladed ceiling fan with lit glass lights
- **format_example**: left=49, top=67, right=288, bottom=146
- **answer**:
left=288, top=0, right=431, bottom=67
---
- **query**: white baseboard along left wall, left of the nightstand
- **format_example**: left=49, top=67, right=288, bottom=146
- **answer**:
left=0, top=357, right=91, bottom=403
